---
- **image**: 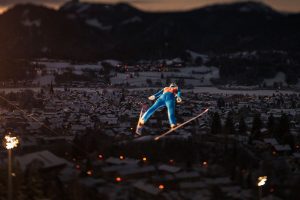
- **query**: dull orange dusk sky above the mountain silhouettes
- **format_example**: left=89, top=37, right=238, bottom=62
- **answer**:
left=0, top=0, right=300, bottom=12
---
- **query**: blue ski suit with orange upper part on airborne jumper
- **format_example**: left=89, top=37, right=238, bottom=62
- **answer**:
left=142, top=87, right=181, bottom=125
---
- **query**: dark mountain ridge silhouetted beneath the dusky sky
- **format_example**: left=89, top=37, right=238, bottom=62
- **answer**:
left=0, top=2, right=300, bottom=60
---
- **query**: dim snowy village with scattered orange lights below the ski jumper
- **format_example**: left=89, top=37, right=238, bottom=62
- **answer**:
left=0, top=83, right=300, bottom=200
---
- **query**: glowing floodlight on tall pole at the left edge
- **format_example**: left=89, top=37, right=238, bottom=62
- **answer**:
left=4, top=133, right=19, bottom=200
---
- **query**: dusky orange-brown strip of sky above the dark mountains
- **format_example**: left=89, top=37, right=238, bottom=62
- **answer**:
left=0, top=0, right=300, bottom=14
